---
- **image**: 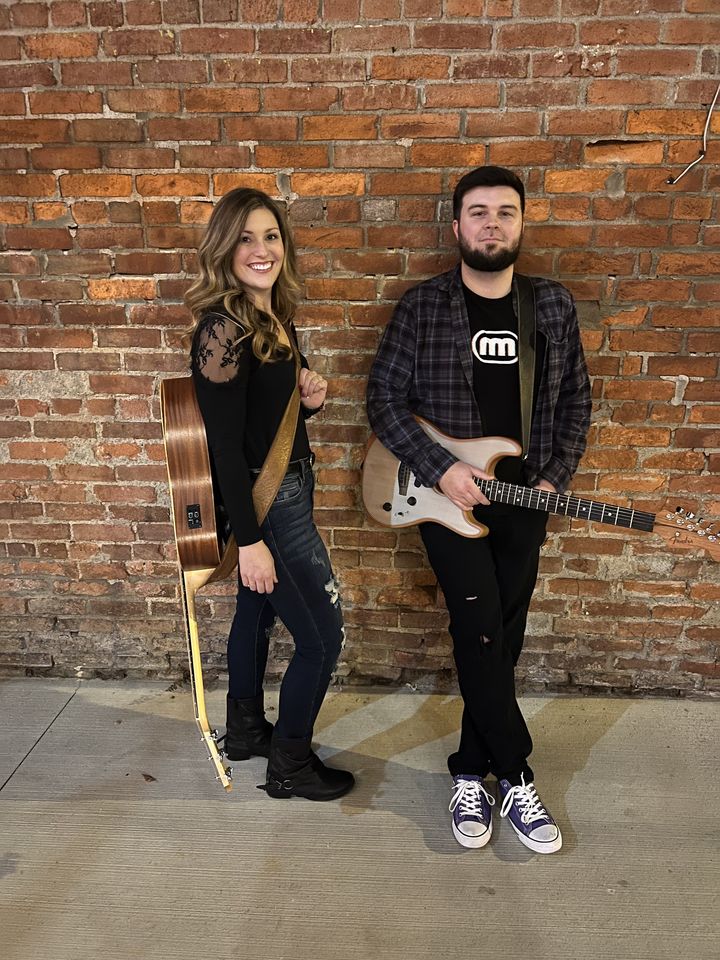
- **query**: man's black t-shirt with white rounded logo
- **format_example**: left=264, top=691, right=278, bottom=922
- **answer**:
left=463, top=284, right=544, bottom=483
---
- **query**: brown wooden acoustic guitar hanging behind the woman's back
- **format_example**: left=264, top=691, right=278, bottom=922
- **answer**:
left=160, top=377, right=237, bottom=790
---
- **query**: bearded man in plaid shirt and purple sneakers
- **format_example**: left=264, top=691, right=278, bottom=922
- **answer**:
left=367, top=166, right=590, bottom=853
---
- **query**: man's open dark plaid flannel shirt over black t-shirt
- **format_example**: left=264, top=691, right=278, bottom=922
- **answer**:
left=367, top=266, right=591, bottom=491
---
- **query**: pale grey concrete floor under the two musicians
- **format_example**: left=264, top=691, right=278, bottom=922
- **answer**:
left=0, top=680, right=720, bottom=960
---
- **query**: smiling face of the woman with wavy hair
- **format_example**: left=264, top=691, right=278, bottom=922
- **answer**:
left=232, top=207, right=285, bottom=310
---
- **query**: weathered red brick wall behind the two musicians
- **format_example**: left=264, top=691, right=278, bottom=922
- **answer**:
left=0, top=0, right=720, bottom=692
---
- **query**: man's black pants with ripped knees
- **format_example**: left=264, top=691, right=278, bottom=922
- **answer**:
left=420, top=504, right=547, bottom=784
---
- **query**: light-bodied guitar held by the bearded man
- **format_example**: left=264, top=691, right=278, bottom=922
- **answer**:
left=362, top=417, right=720, bottom=560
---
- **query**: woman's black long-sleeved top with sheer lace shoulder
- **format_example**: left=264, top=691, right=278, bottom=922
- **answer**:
left=191, top=307, right=310, bottom=547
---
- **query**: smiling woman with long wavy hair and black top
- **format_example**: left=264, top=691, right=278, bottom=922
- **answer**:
left=186, top=189, right=354, bottom=800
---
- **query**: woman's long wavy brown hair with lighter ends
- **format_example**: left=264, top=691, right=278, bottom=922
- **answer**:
left=185, top=187, right=300, bottom=362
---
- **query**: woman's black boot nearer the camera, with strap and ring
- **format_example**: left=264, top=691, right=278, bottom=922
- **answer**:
left=263, top=737, right=355, bottom=800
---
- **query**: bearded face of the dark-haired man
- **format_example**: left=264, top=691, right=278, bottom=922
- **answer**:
left=453, top=187, right=523, bottom=272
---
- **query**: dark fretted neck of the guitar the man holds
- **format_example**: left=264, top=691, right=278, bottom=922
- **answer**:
left=475, top=477, right=655, bottom=532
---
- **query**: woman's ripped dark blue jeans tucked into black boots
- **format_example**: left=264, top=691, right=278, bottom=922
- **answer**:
left=227, top=460, right=345, bottom=739
